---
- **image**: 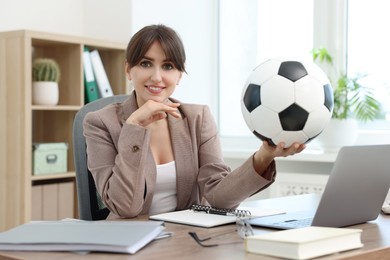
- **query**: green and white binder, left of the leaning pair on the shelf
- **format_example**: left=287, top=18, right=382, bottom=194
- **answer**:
left=83, top=46, right=99, bottom=104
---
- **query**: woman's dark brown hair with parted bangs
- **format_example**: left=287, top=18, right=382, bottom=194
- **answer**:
left=126, top=24, right=186, bottom=72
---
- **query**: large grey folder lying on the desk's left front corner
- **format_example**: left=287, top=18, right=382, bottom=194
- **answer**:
left=0, top=220, right=164, bottom=254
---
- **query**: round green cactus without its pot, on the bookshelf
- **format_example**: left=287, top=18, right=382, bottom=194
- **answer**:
left=32, top=58, right=60, bottom=83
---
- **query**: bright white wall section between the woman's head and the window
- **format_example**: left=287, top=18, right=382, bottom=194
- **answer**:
left=131, top=0, right=218, bottom=112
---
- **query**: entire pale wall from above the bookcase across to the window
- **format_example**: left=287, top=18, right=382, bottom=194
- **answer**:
left=0, top=0, right=218, bottom=115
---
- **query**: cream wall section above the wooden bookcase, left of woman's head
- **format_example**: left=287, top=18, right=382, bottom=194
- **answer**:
left=0, top=0, right=131, bottom=42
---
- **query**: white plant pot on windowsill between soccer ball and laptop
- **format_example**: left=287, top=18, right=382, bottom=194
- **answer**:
left=316, top=118, right=358, bottom=152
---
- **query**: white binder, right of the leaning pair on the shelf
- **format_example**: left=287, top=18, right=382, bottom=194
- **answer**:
left=90, top=50, right=114, bottom=97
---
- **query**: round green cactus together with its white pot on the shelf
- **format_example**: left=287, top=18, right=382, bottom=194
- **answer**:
left=32, top=58, right=60, bottom=105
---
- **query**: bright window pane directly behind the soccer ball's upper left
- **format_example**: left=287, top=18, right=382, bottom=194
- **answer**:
left=219, top=0, right=313, bottom=136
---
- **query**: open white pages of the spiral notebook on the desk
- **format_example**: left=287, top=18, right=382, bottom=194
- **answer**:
left=149, top=207, right=285, bottom=228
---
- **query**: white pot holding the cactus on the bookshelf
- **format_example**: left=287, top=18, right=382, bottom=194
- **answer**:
left=32, top=81, right=59, bottom=106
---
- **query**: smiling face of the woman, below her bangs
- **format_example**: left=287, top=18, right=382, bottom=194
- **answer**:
left=126, top=42, right=182, bottom=106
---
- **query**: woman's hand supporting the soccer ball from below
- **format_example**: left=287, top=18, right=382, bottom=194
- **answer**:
left=253, top=141, right=306, bottom=174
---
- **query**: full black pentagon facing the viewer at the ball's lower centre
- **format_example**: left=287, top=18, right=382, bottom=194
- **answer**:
left=279, top=103, right=309, bottom=131
